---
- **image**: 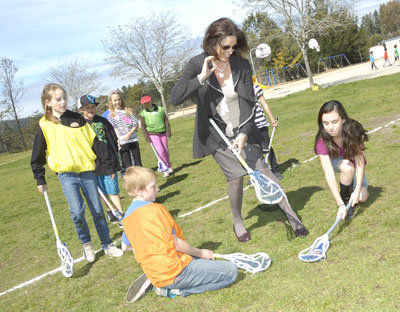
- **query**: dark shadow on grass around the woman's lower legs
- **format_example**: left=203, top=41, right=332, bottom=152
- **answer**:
left=245, top=186, right=322, bottom=239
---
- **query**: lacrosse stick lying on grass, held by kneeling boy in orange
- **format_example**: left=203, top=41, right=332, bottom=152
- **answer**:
left=214, top=252, right=272, bottom=274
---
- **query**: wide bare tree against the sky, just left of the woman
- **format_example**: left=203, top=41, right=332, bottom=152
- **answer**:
left=103, top=13, right=194, bottom=111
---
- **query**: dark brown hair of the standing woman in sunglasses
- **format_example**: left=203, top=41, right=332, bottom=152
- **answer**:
left=202, top=17, right=249, bottom=56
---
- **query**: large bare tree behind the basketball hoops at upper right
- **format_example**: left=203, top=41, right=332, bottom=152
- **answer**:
left=243, top=0, right=356, bottom=86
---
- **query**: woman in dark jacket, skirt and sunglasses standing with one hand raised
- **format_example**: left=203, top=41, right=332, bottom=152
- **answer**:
left=171, top=18, right=307, bottom=242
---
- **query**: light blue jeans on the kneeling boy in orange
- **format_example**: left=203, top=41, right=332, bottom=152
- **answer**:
left=164, top=258, right=238, bottom=297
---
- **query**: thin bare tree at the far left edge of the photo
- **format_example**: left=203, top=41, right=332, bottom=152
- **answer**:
left=0, top=57, right=27, bottom=149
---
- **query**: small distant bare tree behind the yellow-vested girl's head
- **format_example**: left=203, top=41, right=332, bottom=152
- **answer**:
left=46, top=59, right=101, bottom=108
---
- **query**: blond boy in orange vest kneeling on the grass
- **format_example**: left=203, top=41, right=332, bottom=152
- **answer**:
left=122, top=167, right=238, bottom=302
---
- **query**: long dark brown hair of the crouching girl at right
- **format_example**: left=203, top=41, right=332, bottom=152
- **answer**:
left=314, top=101, right=369, bottom=159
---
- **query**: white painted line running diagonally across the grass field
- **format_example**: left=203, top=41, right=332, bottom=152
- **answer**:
left=0, top=118, right=400, bottom=297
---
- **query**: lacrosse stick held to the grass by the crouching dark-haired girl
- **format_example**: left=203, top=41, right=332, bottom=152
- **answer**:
left=299, top=202, right=351, bottom=262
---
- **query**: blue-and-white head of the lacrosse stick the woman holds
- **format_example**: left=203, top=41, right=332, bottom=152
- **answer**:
left=249, top=170, right=283, bottom=205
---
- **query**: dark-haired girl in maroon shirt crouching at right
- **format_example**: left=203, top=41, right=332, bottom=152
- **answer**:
left=315, top=101, right=369, bottom=219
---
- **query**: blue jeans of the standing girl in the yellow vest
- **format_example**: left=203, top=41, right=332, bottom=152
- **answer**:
left=58, top=171, right=112, bottom=249
